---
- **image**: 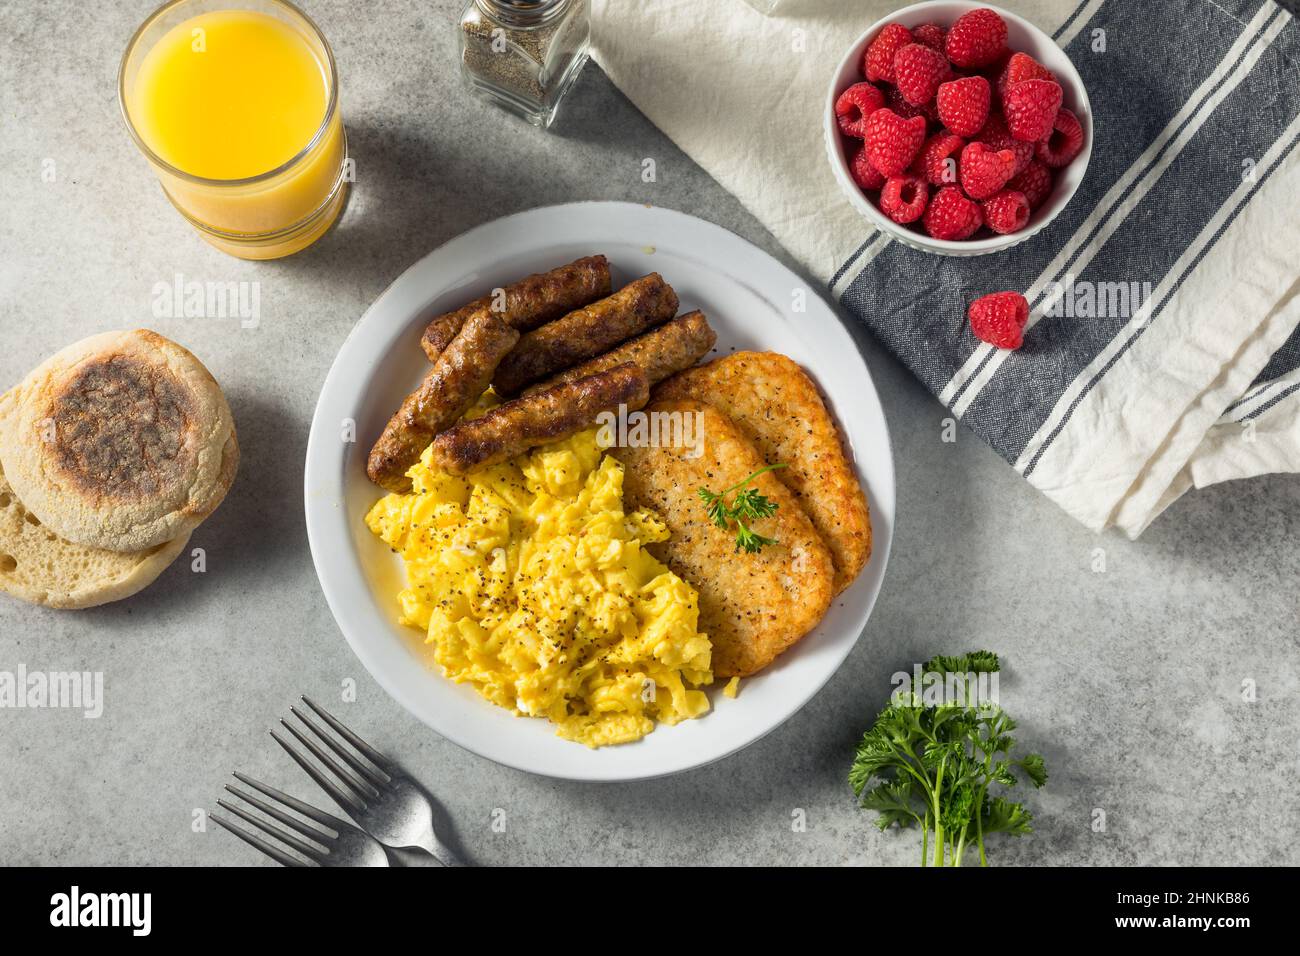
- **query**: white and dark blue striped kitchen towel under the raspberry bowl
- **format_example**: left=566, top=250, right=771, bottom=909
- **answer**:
left=597, top=0, right=1300, bottom=537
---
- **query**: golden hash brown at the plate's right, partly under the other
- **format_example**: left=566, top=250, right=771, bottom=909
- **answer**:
left=651, top=351, right=871, bottom=593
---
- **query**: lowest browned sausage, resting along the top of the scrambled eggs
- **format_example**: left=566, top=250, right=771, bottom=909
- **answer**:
left=432, top=362, right=650, bottom=475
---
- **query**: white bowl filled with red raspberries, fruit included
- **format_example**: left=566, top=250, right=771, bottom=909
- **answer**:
left=826, top=1, right=1092, bottom=255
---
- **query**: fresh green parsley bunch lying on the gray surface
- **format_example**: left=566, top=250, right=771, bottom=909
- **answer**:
left=849, top=650, right=1048, bottom=866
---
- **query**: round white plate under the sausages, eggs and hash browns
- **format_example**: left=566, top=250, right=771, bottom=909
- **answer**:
left=306, top=203, right=894, bottom=780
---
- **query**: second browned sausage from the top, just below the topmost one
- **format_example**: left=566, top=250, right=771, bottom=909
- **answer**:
left=491, top=272, right=677, bottom=397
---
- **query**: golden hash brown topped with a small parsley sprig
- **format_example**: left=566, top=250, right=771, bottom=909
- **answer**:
left=611, top=401, right=835, bottom=678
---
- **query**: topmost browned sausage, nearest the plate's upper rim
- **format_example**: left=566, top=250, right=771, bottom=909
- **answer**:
left=420, top=256, right=611, bottom=362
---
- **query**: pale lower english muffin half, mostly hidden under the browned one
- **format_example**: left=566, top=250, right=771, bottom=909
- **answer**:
left=0, top=473, right=190, bottom=607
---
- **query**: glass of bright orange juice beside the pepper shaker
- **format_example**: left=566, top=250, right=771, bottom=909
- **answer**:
left=118, top=0, right=351, bottom=259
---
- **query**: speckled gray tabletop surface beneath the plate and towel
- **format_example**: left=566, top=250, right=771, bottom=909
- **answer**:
left=0, top=0, right=1300, bottom=865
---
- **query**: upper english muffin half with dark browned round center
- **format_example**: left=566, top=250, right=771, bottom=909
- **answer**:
left=0, top=329, right=239, bottom=553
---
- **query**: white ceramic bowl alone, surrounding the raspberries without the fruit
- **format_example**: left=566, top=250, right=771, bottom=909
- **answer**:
left=823, top=0, right=1092, bottom=256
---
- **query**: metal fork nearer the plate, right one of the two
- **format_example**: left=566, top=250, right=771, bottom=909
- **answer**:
left=270, top=697, right=464, bottom=866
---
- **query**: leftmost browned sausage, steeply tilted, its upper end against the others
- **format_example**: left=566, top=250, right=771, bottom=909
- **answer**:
left=365, top=310, right=519, bottom=493
